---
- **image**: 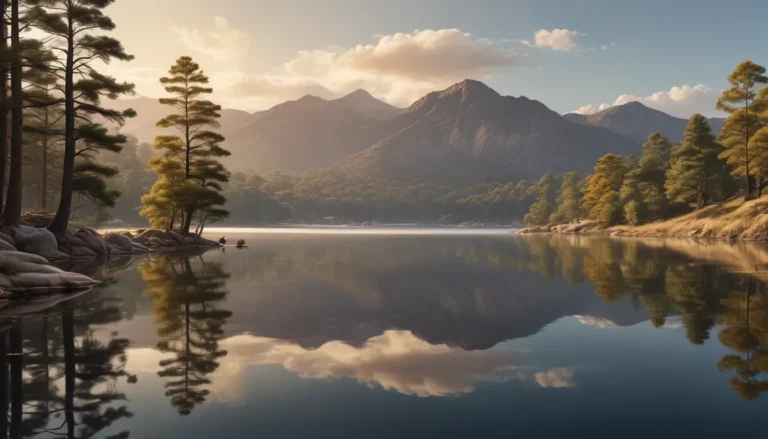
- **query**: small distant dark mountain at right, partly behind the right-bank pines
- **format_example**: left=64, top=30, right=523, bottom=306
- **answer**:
left=563, top=102, right=724, bottom=144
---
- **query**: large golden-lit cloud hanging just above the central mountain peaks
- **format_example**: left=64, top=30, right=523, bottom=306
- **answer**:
left=218, top=29, right=518, bottom=106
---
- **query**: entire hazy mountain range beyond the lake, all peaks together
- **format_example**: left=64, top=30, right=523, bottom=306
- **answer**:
left=111, top=80, right=722, bottom=185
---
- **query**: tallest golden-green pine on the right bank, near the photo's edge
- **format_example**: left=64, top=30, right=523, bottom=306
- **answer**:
left=717, top=61, right=768, bottom=200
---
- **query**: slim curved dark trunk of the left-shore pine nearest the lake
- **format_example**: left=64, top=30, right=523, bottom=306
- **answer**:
left=48, top=22, right=77, bottom=238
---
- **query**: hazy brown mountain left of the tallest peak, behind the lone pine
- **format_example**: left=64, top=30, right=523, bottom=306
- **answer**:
left=108, top=90, right=403, bottom=172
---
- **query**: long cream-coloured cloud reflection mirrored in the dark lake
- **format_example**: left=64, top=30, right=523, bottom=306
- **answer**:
left=126, top=330, right=573, bottom=402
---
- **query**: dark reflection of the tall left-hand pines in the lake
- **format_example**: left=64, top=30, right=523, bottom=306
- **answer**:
left=0, top=284, right=133, bottom=438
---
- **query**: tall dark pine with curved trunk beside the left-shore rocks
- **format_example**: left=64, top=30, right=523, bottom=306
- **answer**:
left=29, top=0, right=135, bottom=238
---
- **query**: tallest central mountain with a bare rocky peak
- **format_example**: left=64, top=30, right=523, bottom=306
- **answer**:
left=334, top=80, right=640, bottom=184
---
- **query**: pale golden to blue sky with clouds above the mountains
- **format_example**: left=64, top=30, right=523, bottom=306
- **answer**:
left=102, top=0, right=768, bottom=117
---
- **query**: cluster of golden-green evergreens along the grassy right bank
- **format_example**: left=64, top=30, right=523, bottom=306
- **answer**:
left=526, top=61, right=768, bottom=230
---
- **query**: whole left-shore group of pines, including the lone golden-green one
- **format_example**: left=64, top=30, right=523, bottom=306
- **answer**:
left=0, top=0, right=229, bottom=239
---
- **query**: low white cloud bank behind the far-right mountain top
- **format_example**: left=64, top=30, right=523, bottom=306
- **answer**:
left=573, top=84, right=719, bottom=119
